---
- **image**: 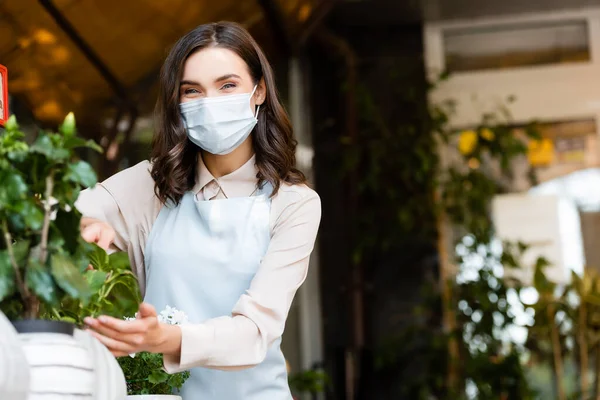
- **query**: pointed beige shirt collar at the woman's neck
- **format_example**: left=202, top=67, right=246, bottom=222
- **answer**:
left=193, top=156, right=258, bottom=197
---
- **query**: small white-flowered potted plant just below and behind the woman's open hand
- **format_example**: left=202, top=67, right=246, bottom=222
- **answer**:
left=118, top=306, right=190, bottom=400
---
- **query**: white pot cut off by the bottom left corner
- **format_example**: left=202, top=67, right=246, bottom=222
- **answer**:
left=0, top=311, right=29, bottom=400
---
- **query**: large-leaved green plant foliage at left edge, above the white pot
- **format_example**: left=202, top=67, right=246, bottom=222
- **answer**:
left=0, top=114, right=105, bottom=319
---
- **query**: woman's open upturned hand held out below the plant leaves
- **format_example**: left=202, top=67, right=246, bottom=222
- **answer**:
left=84, top=303, right=181, bottom=357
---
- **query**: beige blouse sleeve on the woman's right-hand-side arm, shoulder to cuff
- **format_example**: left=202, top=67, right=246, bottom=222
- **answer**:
left=165, top=185, right=321, bottom=373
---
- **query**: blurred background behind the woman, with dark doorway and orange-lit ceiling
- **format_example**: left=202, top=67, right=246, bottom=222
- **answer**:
left=5, top=0, right=600, bottom=400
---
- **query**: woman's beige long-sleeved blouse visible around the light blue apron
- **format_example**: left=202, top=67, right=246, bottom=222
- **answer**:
left=77, top=157, right=321, bottom=373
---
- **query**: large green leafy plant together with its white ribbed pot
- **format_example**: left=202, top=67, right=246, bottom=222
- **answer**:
left=0, top=114, right=130, bottom=400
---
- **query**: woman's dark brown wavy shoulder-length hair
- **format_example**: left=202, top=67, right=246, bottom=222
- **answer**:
left=151, top=22, right=306, bottom=204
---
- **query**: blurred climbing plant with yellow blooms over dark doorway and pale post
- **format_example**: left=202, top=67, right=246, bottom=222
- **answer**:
left=344, top=67, right=539, bottom=399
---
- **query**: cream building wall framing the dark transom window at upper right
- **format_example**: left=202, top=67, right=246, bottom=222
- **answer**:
left=424, top=8, right=600, bottom=131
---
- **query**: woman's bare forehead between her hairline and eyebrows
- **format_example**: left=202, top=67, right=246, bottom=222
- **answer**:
left=182, top=47, right=250, bottom=82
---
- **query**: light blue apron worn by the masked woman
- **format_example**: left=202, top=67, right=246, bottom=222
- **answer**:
left=145, top=184, right=292, bottom=400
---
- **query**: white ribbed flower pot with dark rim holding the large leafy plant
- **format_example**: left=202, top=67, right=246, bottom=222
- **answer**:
left=13, top=320, right=127, bottom=400
